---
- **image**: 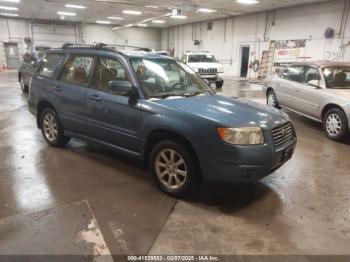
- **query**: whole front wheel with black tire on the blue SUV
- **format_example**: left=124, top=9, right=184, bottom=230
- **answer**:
left=149, top=140, right=199, bottom=197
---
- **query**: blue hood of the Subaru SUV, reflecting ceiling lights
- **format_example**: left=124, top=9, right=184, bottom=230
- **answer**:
left=155, top=94, right=289, bottom=129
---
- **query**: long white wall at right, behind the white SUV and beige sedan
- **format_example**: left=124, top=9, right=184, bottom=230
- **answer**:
left=161, top=0, right=350, bottom=77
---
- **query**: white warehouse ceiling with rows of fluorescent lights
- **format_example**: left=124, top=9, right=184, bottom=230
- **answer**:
left=0, top=0, right=327, bottom=27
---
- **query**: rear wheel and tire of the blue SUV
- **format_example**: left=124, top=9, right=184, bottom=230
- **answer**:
left=40, top=107, right=70, bottom=147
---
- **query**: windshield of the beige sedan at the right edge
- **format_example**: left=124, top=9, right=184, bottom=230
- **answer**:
left=322, top=66, right=350, bottom=89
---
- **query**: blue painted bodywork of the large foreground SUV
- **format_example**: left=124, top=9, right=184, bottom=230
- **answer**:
left=28, top=49, right=296, bottom=181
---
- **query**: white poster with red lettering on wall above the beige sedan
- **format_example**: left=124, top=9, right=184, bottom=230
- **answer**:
left=270, top=39, right=306, bottom=63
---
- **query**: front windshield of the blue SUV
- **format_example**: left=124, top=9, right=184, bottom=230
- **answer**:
left=130, top=58, right=213, bottom=98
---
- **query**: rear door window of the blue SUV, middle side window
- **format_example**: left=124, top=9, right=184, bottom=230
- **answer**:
left=60, top=55, right=94, bottom=86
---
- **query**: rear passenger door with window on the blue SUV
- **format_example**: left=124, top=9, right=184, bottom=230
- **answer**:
left=52, top=54, right=94, bottom=134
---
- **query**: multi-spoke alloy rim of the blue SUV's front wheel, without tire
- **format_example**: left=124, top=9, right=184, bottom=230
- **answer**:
left=156, top=149, right=187, bottom=189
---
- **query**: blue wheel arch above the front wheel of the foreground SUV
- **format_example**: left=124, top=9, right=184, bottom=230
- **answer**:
left=143, top=128, right=201, bottom=174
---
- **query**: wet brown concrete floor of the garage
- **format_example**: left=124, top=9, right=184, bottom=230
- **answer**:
left=0, top=72, right=350, bottom=255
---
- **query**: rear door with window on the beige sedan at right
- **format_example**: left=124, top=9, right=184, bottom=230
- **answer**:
left=275, top=65, right=303, bottom=109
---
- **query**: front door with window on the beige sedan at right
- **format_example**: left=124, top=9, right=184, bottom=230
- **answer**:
left=294, top=66, right=324, bottom=118
